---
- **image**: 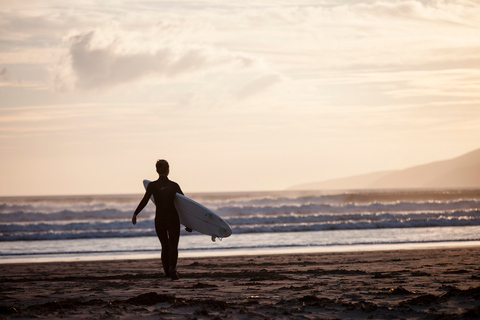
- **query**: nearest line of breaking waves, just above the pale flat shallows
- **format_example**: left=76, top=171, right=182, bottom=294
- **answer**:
left=0, top=210, right=480, bottom=241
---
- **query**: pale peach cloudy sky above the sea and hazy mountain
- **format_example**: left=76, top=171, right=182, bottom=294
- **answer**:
left=0, top=0, right=480, bottom=196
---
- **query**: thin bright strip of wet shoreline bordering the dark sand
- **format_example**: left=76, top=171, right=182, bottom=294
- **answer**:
left=0, top=240, right=480, bottom=265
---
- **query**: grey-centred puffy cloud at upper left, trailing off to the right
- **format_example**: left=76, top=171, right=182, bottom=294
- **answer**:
left=62, top=31, right=260, bottom=89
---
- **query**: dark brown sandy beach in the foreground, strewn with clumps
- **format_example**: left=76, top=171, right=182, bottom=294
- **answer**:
left=0, top=247, right=480, bottom=319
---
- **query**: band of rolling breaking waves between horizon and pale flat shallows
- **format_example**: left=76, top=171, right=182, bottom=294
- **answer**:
left=0, top=191, right=480, bottom=241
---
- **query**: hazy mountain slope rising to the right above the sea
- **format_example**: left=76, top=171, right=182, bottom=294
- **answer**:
left=289, top=149, right=480, bottom=190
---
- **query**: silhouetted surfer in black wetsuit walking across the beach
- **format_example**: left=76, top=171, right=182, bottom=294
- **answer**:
left=132, top=160, right=183, bottom=280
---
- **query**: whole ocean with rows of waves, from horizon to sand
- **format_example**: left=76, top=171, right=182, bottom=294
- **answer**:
left=0, top=190, right=480, bottom=263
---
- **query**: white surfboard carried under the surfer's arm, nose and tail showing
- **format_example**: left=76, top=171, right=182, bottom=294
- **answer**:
left=143, top=180, right=232, bottom=241
